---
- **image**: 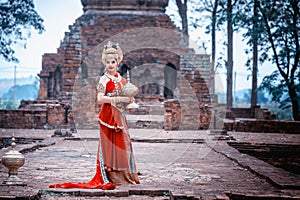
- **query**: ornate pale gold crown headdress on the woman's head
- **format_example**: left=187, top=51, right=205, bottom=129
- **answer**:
left=102, top=41, right=123, bottom=65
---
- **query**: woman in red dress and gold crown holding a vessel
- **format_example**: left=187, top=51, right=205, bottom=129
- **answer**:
left=50, top=42, right=140, bottom=190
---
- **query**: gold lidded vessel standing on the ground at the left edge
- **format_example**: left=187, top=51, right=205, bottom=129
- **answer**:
left=1, top=134, right=25, bottom=185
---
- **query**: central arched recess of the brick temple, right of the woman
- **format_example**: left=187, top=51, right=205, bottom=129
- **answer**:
left=124, top=49, right=179, bottom=105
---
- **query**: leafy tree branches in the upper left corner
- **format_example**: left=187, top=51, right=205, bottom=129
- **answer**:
left=0, top=0, right=44, bottom=62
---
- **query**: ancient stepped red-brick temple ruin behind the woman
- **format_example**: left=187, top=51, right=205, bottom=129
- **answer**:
left=0, top=0, right=214, bottom=130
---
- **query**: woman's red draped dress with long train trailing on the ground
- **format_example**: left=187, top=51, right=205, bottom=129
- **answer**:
left=49, top=72, right=139, bottom=190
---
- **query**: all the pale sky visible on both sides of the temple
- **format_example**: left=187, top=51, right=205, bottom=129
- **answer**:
left=0, top=0, right=270, bottom=91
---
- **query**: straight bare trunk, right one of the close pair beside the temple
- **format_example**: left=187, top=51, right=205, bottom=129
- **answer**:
left=226, top=0, right=233, bottom=109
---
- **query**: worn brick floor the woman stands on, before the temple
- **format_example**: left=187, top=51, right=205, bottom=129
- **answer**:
left=0, top=129, right=300, bottom=199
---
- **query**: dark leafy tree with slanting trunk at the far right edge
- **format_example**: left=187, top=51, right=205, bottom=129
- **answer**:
left=258, top=0, right=300, bottom=120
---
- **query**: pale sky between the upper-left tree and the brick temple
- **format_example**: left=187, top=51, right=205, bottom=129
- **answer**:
left=0, top=0, right=83, bottom=78
